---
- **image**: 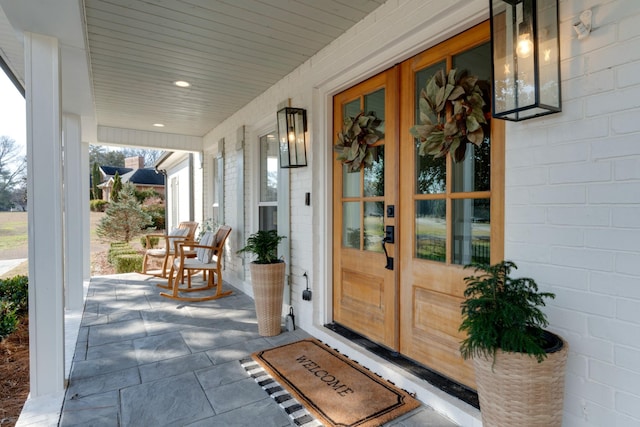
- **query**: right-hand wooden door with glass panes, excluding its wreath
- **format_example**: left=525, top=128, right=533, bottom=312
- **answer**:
left=399, top=23, right=504, bottom=387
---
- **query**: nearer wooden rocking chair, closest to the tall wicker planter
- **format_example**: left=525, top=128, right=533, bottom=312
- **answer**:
left=157, top=225, right=232, bottom=301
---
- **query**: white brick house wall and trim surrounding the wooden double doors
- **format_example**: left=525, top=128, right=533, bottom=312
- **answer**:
left=198, top=0, right=640, bottom=427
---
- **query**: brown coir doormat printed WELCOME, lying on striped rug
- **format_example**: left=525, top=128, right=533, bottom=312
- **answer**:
left=245, top=338, right=420, bottom=427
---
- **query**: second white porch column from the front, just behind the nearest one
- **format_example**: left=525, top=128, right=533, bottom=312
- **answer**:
left=62, top=114, right=89, bottom=310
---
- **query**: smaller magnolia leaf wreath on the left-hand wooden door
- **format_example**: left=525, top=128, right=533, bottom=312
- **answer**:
left=333, top=112, right=382, bottom=172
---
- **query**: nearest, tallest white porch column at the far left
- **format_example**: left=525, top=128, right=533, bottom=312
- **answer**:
left=24, top=32, right=64, bottom=398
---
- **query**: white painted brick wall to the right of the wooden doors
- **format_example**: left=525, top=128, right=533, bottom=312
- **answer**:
left=505, top=0, right=640, bottom=426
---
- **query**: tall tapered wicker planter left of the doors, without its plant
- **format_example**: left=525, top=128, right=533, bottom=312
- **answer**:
left=249, top=262, right=285, bottom=337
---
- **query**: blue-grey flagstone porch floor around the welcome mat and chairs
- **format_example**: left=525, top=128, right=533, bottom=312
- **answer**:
left=26, top=274, right=455, bottom=427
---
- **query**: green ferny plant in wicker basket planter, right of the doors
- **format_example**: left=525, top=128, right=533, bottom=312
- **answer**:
left=460, top=261, right=568, bottom=427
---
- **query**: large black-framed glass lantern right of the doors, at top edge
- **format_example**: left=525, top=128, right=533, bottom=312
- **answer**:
left=489, top=0, right=562, bottom=121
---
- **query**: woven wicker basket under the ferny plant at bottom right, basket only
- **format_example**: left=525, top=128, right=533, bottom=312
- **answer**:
left=473, top=337, right=569, bottom=427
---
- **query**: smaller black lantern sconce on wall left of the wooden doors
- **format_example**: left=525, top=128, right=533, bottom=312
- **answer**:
left=278, top=107, right=307, bottom=168
